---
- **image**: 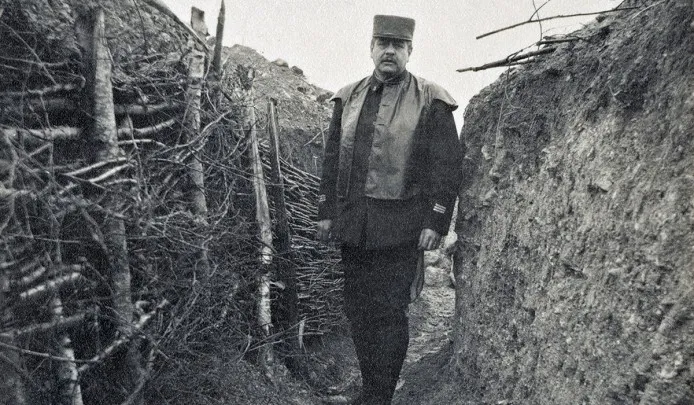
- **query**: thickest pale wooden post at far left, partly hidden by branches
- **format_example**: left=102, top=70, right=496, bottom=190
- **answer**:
left=87, top=8, right=144, bottom=405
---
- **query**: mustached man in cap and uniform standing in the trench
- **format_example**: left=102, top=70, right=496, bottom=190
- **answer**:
left=317, top=15, right=464, bottom=405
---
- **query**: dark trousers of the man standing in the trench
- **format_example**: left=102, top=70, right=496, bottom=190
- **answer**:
left=342, top=243, right=418, bottom=405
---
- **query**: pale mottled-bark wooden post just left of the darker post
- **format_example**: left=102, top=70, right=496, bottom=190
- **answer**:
left=245, top=69, right=274, bottom=377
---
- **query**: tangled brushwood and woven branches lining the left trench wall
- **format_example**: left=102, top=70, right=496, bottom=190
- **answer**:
left=0, top=0, right=341, bottom=404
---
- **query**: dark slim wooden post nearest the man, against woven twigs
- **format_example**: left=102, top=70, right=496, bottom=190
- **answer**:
left=267, top=99, right=299, bottom=346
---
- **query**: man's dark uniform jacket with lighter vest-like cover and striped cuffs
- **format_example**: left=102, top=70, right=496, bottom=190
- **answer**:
left=319, top=71, right=464, bottom=248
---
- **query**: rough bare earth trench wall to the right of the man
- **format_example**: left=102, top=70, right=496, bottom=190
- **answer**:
left=452, top=0, right=694, bottom=404
